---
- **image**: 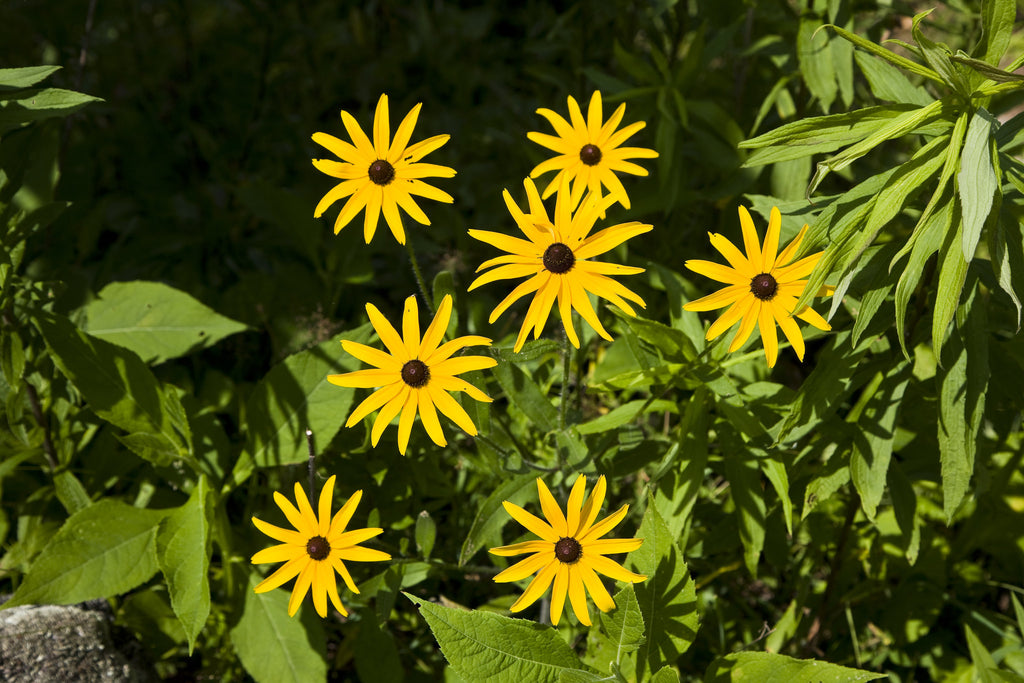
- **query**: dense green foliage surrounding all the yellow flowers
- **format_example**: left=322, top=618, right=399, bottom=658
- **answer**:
left=0, top=0, right=1024, bottom=683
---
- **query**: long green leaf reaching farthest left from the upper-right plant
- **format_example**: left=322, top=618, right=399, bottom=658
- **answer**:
left=739, top=104, right=919, bottom=167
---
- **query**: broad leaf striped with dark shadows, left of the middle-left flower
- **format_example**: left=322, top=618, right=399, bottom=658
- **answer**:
left=231, top=323, right=372, bottom=485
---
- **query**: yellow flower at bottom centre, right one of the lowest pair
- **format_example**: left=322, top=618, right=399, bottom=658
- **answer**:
left=490, top=474, right=647, bottom=626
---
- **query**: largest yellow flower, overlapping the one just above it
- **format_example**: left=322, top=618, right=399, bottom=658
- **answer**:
left=469, top=178, right=651, bottom=352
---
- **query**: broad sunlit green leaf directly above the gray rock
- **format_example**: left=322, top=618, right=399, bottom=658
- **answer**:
left=2, top=499, right=165, bottom=608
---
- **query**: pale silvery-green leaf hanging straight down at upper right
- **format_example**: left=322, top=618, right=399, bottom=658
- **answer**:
left=956, top=108, right=998, bottom=262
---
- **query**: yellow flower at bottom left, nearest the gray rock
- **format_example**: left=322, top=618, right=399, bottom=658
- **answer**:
left=252, top=476, right=391, bottom=616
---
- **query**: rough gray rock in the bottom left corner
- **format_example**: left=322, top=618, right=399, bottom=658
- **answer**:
left=0, top=600, right=157, bottom=683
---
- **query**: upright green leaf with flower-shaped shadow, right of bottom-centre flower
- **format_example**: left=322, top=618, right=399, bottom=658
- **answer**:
left=626, top=496, right=700, bottom=680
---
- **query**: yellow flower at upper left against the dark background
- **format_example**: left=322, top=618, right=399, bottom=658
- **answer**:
left=313, top=95, right=455, bottom=244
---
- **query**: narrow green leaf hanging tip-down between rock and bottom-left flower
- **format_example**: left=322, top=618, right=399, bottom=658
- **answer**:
left=157, top=476, right=216, bottom=654
